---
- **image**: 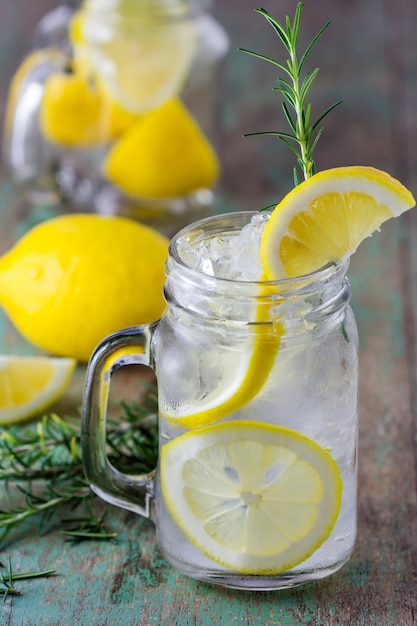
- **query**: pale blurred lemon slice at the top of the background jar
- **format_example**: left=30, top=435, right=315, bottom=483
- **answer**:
left=70, top=0, right=197, bottom=113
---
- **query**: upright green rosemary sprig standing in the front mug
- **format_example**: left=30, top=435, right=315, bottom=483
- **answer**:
left=241, top=2, right=342, bottom=185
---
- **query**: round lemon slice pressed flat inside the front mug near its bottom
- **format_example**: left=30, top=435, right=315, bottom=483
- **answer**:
left=161, top=421, right=342, bottom=574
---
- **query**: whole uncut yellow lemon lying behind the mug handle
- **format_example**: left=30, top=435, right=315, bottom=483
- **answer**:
left=0, top=213, right=168, bottom=361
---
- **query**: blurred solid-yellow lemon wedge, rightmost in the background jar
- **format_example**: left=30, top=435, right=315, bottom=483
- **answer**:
left=103, top=98, right=220, bottom=198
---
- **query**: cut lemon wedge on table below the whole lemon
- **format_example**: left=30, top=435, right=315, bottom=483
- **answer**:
left=0, top=355, right=76, bottom=425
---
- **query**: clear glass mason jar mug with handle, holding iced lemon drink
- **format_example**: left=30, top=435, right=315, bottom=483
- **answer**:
left=82, top=213, right=358, bottom=590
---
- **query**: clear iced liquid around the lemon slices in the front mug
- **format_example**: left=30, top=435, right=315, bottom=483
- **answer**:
left=156, top=316, right=357, bottom=590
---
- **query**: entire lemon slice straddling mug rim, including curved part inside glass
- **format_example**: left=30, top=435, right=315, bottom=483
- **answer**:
left=163, top=166, right=415, bottom=428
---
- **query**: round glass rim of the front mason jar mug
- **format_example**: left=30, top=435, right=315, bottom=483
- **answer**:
left=167, top=211, right=349, bottom=293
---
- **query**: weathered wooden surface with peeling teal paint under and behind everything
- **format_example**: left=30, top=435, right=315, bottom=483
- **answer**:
left=0, top=0, right=417, bottom=626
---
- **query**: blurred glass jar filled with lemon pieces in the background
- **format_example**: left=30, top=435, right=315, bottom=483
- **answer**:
left=4, top=0, right=229, bottom=234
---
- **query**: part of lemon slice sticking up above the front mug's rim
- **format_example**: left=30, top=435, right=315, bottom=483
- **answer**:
left=261, top=166, right=415, bottom=280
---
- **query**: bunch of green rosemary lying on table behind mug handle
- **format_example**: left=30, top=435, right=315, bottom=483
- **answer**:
left=0, top=386, right=158, bottom=546
